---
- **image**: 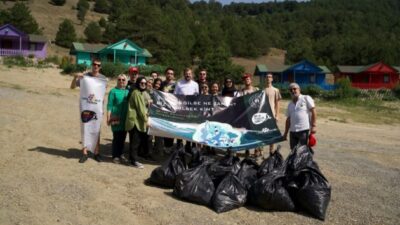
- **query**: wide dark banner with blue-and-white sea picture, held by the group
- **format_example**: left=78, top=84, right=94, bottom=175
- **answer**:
left=149, top=91, right=283, bottom=151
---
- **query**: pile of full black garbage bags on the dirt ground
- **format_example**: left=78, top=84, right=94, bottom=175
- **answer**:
left=150, top=145, right=331, bottom=220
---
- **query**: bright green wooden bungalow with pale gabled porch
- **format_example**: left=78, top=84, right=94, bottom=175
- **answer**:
left=70, top=39, right=152, bottom=66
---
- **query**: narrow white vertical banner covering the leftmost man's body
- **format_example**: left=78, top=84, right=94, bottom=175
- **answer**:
left=79, top=76, right=107, bottom=152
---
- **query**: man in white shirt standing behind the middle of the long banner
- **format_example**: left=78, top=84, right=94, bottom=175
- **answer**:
left=174, top=68, right=199, bottom=152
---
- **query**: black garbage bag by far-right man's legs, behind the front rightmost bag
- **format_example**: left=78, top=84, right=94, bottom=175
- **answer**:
left=285, top=145, right=314, bottom=173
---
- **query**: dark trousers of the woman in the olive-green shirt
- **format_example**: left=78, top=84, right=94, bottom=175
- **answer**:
left=129, top=127, right=149, bottom=162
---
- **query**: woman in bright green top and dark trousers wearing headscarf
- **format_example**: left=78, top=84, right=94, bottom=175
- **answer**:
left=107, top=74, right=129, bottom=163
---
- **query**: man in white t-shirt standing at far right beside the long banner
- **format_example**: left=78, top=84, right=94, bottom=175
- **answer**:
left=283, top=83, right=317, bottom=149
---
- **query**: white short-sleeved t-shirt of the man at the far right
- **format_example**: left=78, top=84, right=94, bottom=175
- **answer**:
left=286, top=95, right=315, bottom=132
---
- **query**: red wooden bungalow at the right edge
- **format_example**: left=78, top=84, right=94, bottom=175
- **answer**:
left=335, top=62, right=400, bottom=89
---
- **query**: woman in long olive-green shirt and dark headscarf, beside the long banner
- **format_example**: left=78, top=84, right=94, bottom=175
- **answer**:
left=125, top=77, right=151, bottom=169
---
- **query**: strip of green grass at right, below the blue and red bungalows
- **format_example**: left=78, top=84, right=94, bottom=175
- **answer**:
left=317, top=98, right=400, bottom=124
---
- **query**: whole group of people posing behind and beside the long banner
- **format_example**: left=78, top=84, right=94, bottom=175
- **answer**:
left=71, top=59, right=316, bottom=169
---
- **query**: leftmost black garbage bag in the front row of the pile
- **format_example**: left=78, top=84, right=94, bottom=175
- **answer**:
left=173, top=164, right=215, bottom=206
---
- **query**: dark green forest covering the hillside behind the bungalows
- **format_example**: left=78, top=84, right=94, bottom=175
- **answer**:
left=0, top=0, right=400, bottom=72
